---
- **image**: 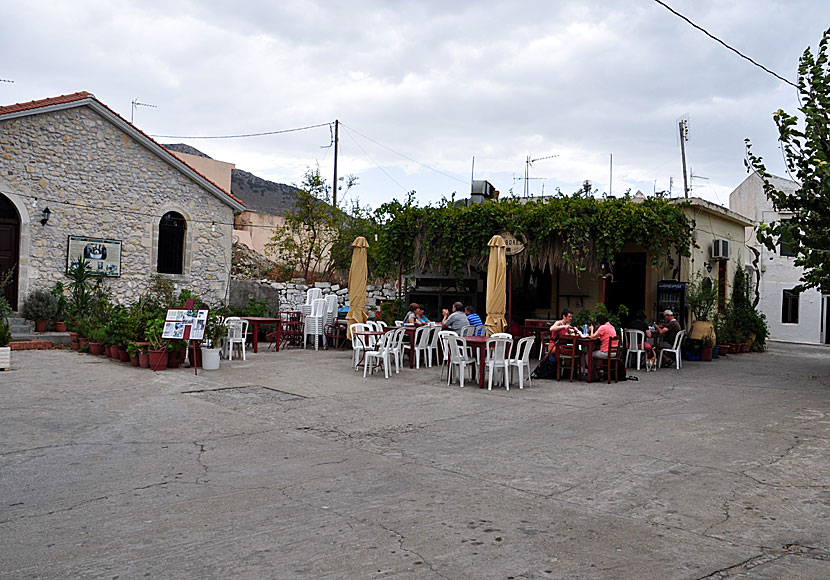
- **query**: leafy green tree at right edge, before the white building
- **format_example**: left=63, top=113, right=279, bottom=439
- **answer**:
left=746, top=29, right=830, bottom=292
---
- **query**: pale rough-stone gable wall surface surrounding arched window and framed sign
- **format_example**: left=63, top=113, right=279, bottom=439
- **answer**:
left=0, top=106, right=233, bottom=303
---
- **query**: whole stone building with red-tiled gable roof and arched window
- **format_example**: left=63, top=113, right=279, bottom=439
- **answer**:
left=0, top=92, right=245, bottom=307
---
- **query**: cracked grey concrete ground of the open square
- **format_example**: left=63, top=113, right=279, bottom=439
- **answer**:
left=0, top=343, right=830, bottom=580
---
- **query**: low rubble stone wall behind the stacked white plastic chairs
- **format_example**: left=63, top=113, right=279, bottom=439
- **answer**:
left=231, top=278, right=398, bottom=311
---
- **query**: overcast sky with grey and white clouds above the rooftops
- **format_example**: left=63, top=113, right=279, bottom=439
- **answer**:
left=0, top=0, right=830, bottom=207
